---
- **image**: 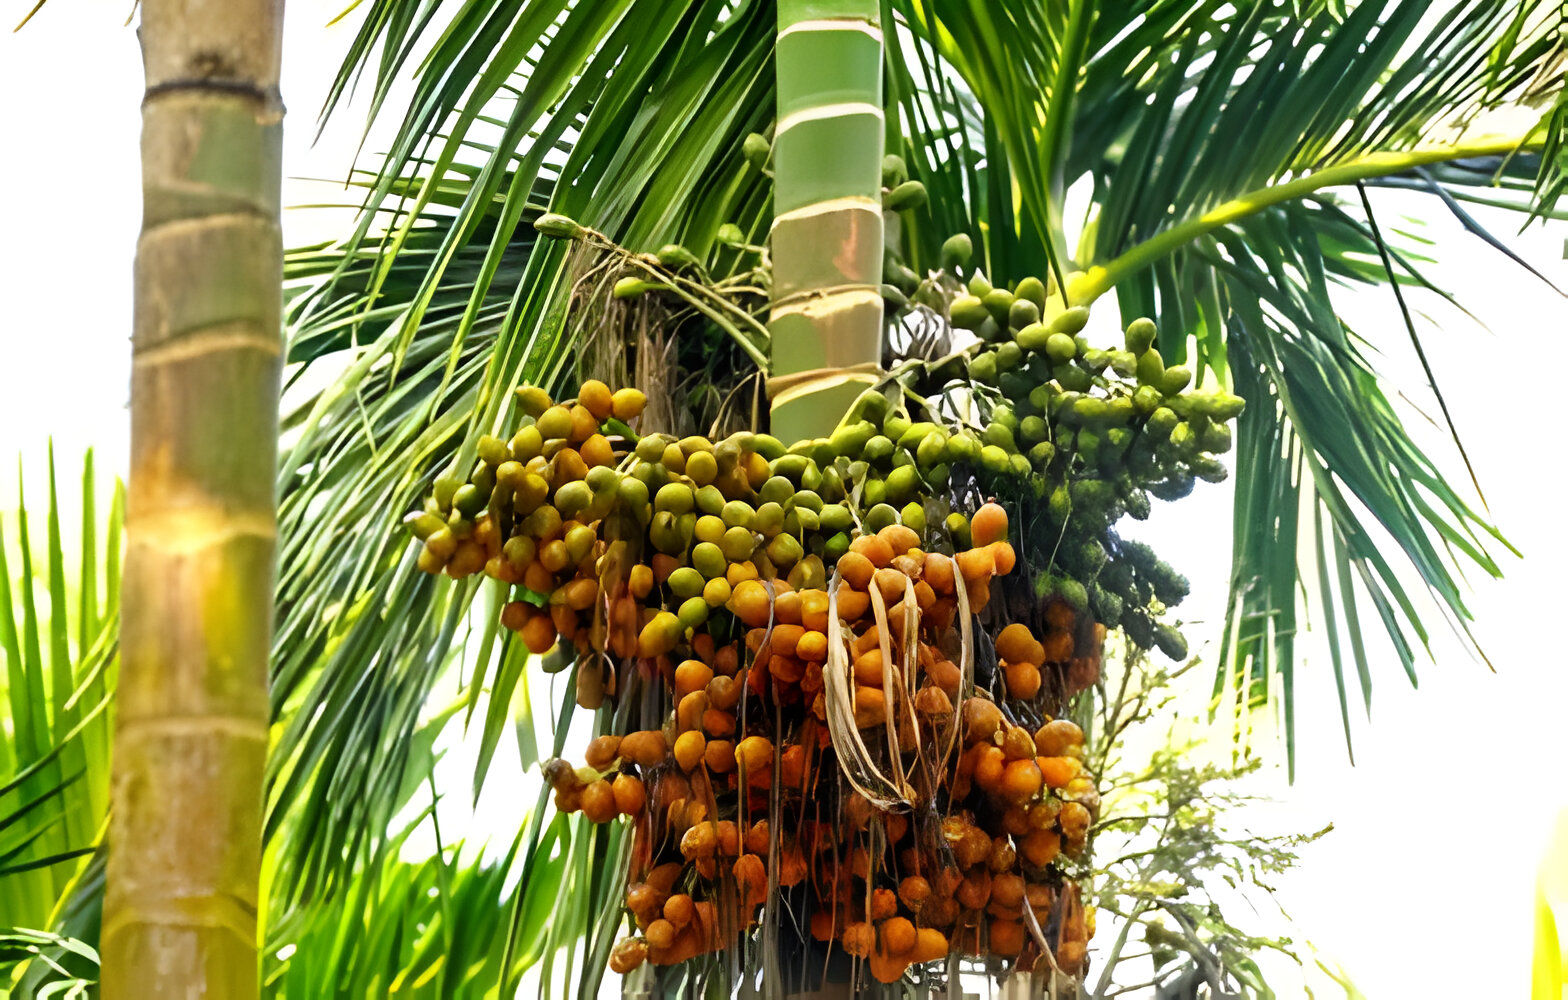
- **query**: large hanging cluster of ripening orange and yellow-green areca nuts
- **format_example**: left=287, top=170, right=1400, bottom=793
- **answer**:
left=408, top=381, right=1105, bottom=983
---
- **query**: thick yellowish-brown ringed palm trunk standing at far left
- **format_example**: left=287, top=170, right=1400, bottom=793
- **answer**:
left=100, top=0, right=282, bottom=1000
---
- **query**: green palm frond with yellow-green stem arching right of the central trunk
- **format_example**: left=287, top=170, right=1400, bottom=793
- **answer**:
left=900, top=0, right=1563, bottom=757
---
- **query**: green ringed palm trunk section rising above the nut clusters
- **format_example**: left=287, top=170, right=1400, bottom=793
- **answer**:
left=768, top=0, right=883, bottom=440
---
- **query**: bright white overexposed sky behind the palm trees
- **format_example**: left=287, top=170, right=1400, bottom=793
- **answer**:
left=0, top=0, right=1568, bottom=998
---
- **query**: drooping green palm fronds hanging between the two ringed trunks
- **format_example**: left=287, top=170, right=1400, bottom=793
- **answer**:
left=268, top=0, right=773, bottom=934
